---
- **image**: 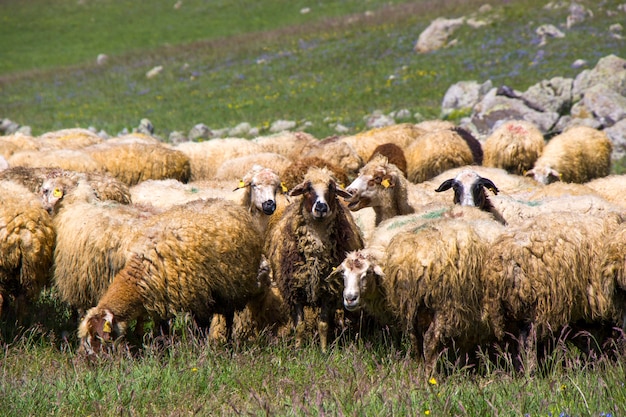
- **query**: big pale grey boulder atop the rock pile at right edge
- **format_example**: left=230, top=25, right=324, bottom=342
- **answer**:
left=572, top=55, right=626, bottom=102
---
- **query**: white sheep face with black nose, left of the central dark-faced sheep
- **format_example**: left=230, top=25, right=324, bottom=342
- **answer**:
left=238, top=165, right=285, bottom=216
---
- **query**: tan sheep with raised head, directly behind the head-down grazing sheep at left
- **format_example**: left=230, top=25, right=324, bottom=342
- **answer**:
left=41, top=176, right=156, bottom=312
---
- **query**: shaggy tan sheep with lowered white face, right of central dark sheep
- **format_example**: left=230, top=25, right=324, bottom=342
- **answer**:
left=332, top=207, right=503, bottom=370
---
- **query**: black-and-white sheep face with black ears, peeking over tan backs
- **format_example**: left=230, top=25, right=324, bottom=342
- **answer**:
left=435, top=170, right=498, bottom=210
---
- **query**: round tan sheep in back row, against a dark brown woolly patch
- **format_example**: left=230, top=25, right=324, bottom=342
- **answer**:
left=404, top=130, right=474, bottom=183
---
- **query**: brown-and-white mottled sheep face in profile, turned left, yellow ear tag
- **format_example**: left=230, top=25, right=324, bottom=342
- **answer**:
left=346, top=161, right=398, bottom=211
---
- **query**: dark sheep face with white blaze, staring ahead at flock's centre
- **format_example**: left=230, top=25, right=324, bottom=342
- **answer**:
left=289, top=168, right=350, bottom=221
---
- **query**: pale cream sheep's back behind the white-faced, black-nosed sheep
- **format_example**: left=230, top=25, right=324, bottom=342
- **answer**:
left=172, top=138, right=263, bottom=181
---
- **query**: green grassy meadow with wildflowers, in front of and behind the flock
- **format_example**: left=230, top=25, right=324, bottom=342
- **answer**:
left=0, top=0, right=626, bottom=417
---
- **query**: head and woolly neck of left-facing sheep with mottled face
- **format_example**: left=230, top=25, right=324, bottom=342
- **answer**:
left=346, top=154, right=415, bottom=226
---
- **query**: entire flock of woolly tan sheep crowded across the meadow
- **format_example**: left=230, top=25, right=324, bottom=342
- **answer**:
left=0, top=120, right=626, bottom=367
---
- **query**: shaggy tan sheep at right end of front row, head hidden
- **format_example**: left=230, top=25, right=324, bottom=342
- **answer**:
left=483, top=211, right=622, bottom=366
